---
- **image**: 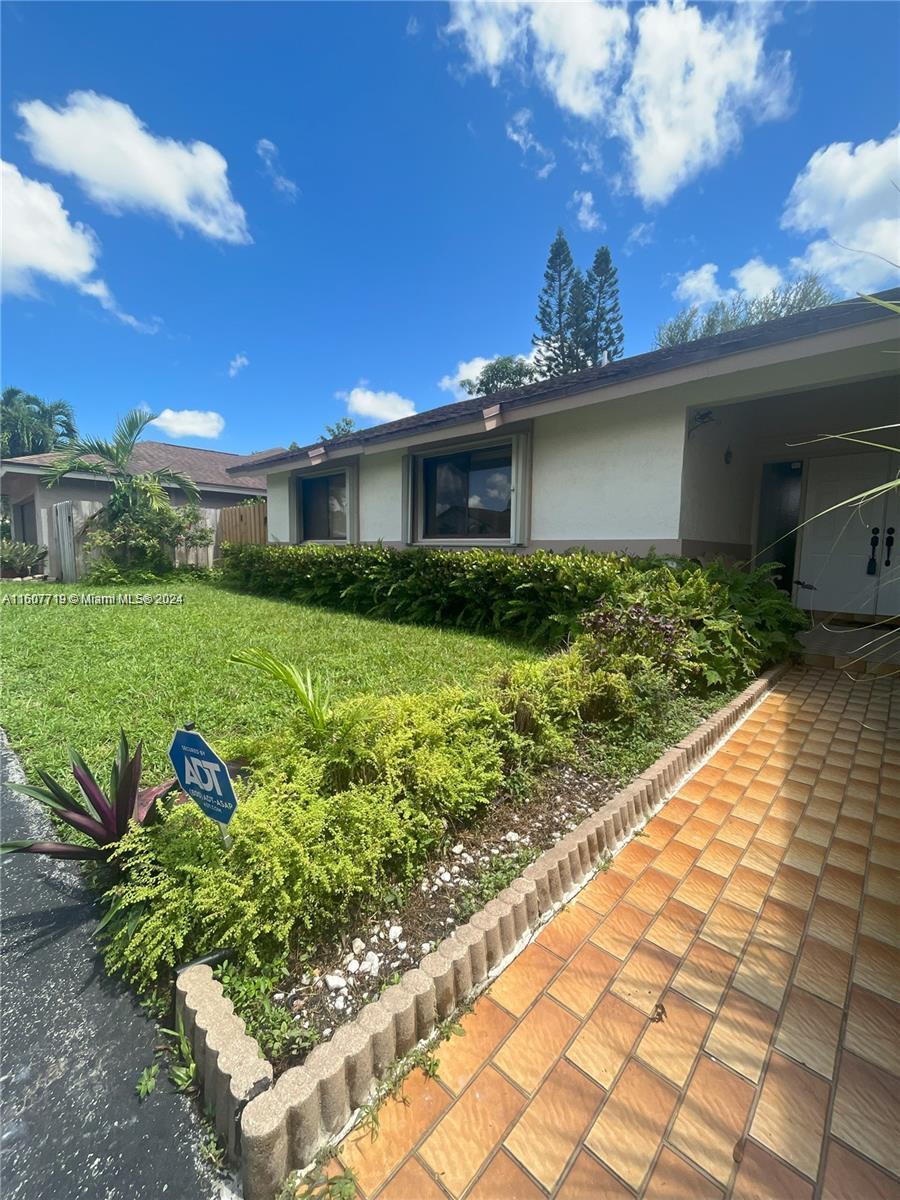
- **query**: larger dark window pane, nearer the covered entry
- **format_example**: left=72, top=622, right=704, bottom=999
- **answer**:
left=422, top=446, right=512, bottom=539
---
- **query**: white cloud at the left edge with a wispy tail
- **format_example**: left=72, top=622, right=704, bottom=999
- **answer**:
left=0, top=162, right=156, bottom=332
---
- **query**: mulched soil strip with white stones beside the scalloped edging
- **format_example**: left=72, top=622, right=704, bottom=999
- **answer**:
left=260, top=766, right=620, bottom=1076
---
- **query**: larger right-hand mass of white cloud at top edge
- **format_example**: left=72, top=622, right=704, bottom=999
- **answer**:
left=613, top=0, right=790, bottom=203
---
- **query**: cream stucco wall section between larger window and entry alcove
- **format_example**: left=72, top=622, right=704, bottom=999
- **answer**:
left=532, top=395, right=684, bottom=544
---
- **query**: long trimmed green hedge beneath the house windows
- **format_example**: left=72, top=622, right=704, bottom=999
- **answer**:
left=223, top=545, right=803, bottom=671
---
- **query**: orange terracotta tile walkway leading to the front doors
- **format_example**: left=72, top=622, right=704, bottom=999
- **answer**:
left=341, top=670, right=900, bottom=1200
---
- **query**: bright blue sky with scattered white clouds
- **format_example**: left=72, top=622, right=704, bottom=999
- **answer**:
left=1, top=0, right=900, bottom=452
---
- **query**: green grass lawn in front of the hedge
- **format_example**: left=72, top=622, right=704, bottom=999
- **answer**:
left=0, top=578, right=536, bottom=784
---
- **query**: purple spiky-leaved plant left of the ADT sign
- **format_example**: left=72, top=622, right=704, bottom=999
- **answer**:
left=0, top=731, right=178, bottom=859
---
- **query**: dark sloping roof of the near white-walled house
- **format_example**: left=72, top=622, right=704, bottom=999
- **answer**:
left=229, top=288, right=900, bottom=473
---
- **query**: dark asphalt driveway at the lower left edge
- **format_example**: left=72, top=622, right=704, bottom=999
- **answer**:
left=0, top=731, right=233, bottom=1200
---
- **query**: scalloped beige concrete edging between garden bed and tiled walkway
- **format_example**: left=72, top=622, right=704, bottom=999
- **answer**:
left=175, top=664, right=788, bottom=1200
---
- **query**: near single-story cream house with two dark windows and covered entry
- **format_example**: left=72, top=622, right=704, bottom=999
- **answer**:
left=232, top=289, right=900, bottom=616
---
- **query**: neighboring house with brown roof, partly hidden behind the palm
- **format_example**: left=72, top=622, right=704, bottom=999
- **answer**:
left=0, top=442, right=265, bottom=578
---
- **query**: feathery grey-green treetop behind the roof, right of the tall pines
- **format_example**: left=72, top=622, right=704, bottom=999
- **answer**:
left=654, top=271, right=838, bottom=349
